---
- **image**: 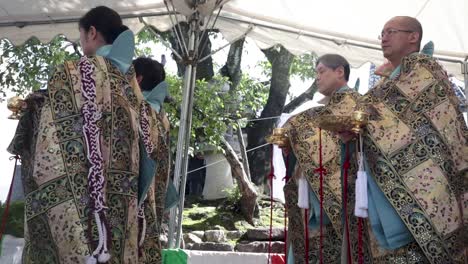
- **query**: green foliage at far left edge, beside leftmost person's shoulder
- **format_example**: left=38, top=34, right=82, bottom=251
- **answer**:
left=0, top=36, right=79, bottom=98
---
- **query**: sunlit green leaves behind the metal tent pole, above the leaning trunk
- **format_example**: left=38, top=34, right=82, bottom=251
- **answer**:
left=165, top=75, right=268, bottom=155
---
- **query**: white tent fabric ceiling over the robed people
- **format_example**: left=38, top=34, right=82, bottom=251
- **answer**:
left=0, top=0, right=468, bottom=79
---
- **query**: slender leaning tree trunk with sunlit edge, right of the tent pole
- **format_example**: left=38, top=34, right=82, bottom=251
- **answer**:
left=222, top=140, right=257, bottom=225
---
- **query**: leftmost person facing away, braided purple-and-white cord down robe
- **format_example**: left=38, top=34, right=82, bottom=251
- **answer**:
left=10, top=6, right=164, bottom=264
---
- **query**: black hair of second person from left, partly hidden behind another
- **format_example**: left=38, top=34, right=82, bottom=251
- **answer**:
left=133, top=57, right=166, bottom=91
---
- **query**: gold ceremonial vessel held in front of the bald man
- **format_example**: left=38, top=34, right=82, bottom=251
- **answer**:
left=317, top=110, right=369, bottom=134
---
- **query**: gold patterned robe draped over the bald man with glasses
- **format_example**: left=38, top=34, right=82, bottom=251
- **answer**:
left=362, top=54, right=468, bottom=263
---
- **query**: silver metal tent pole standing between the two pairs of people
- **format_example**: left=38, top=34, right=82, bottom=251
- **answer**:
left=168, top=11, right=198, bottom=248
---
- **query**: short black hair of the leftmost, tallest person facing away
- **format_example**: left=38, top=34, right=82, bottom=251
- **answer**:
left=78, top=6, right=128, bottom=44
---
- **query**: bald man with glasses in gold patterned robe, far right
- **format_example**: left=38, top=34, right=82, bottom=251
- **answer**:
left=342, top=16, right=468, bottom=263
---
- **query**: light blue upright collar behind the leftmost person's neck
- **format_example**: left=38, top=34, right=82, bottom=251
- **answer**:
left=96, top=30, right=135, bottom=74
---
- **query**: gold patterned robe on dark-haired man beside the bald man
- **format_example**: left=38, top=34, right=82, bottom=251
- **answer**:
left=284, top=88, right=359, bottom=263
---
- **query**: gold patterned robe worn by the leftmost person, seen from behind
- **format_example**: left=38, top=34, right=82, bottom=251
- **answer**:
left=9, top=56, right=164, bottom=264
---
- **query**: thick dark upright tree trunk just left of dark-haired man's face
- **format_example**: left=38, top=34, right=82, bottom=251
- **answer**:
left=247, top=46, right=294, bottom=185
